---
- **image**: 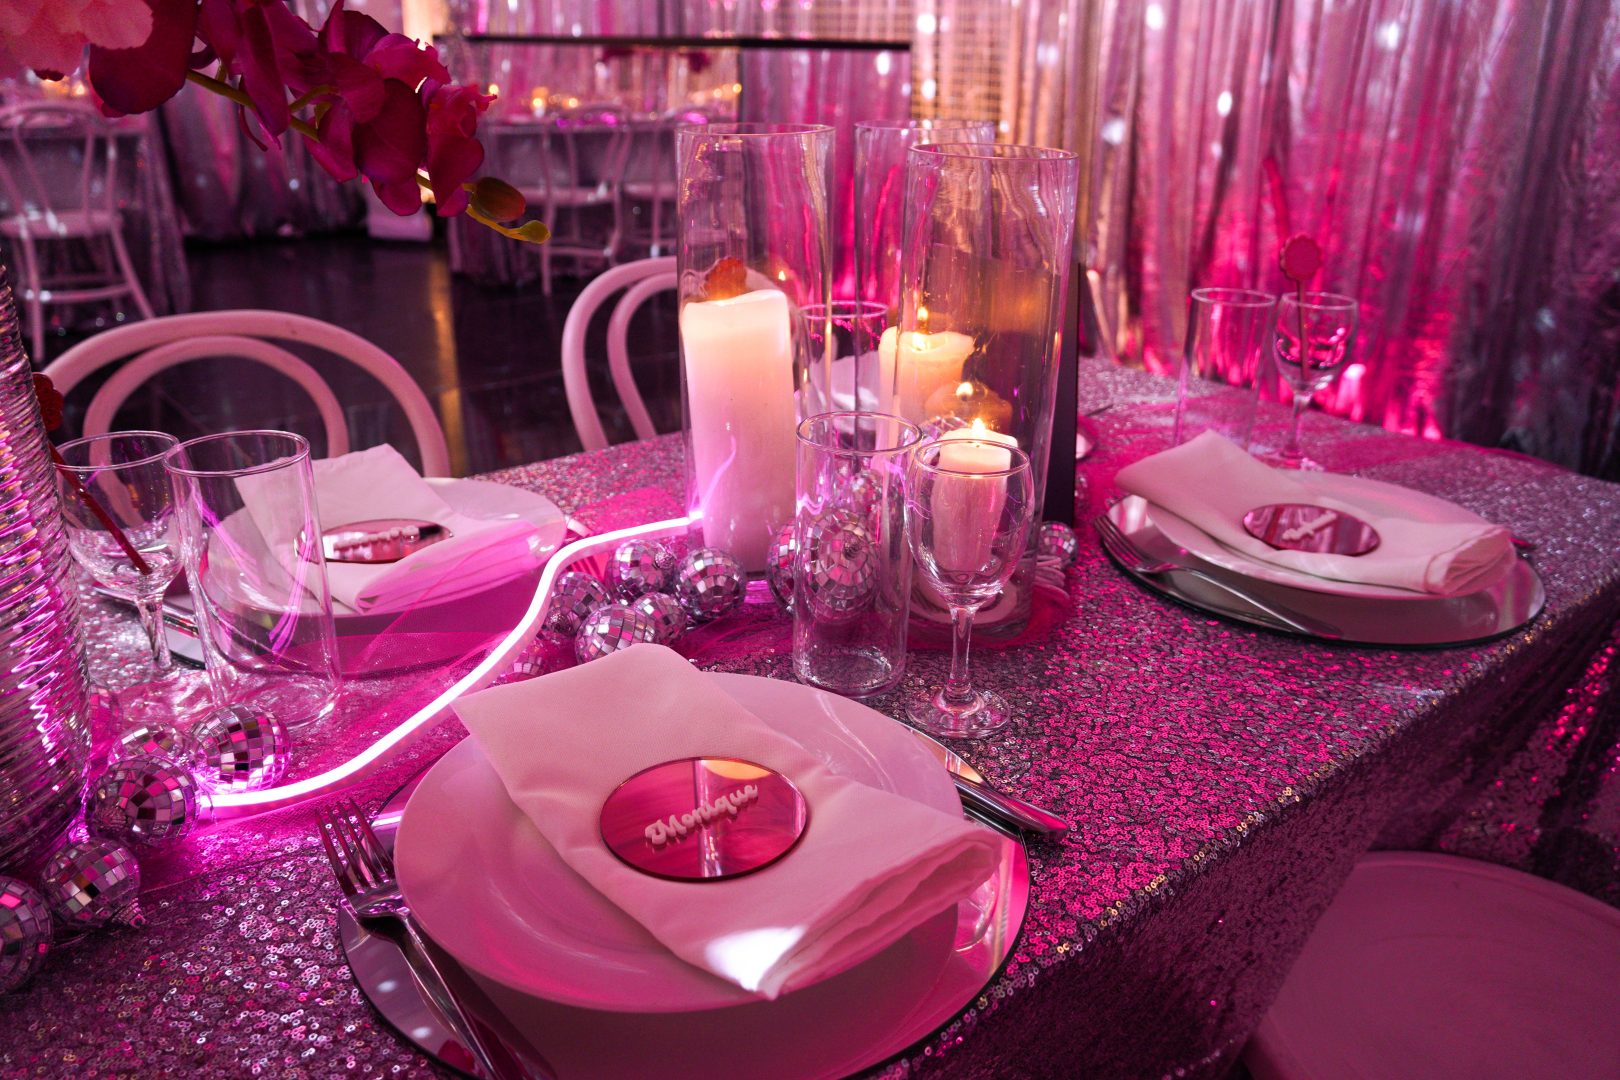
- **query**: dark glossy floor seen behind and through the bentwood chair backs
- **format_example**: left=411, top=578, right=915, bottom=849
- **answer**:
left=53, top=235, right=680, bottom=476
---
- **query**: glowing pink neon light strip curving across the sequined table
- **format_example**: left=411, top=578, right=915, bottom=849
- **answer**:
left=214, top=518, right=692, bottom=819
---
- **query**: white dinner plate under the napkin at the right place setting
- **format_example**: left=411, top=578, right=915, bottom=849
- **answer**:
left=1149, top=473, right=1513, bottom=601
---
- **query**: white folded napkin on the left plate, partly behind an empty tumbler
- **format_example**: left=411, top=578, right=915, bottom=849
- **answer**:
left=238, top=445, right=541, bottom=612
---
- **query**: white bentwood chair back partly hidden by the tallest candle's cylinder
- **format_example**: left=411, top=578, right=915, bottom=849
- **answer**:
left=562, top=256, right=676, bottom=450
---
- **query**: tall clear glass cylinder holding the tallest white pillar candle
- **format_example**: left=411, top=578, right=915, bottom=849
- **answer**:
left=676, top=123, right=833, bottom=573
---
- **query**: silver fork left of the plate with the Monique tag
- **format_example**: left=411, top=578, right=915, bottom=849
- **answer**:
left=316, top=800, right=549, bottom=1080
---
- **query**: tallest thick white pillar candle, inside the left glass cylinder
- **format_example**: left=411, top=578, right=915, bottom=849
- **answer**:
left=680, top=288, right=797, bottom=572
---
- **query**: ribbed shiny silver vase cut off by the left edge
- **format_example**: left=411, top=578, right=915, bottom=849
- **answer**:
left=0, top=267, right=91, bottom=873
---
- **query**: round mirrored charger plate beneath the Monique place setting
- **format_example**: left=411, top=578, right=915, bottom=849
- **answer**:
left=337, top=777, right=1030, bottom=1080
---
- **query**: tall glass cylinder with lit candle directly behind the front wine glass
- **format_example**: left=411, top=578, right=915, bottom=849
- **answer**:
left=900, top=144, right=1079, bottom=640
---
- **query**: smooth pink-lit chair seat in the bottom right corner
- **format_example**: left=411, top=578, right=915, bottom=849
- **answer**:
left=1244, top=852, right=1620, bottom=1080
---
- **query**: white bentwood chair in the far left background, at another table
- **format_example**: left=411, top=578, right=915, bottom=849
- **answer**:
left=0, top=102, right=152, bottom=363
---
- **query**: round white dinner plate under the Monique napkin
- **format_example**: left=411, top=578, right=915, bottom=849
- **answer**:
left=395, top=674, right=961, bottom=1014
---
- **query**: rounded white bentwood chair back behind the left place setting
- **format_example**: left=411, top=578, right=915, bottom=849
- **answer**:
left=45, top=311, right=450, bottom=476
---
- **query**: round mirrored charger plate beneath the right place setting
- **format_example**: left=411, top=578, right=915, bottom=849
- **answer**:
left=1108, top=495, right=1547, bottom=648
